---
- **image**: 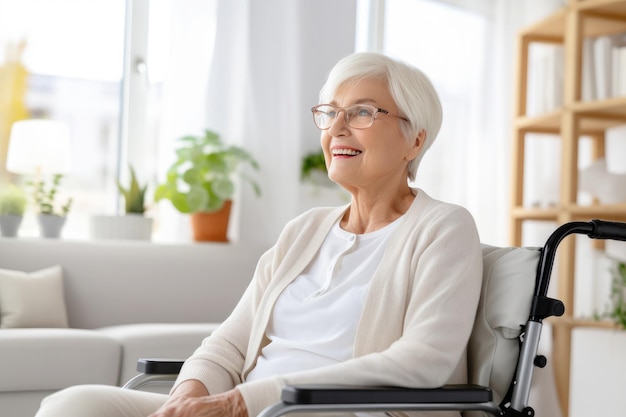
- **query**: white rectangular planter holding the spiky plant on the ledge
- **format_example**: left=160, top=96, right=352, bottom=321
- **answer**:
left=91, top=213, right=152, bottom=240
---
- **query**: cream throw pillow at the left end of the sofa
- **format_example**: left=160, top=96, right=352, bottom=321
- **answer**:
left=0, top=265, right=68, bottom=329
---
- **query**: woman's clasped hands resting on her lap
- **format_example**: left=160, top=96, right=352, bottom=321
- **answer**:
left=149, top=389, right=248, bottom=417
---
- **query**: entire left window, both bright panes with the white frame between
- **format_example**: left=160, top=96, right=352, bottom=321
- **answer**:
left=0, top=0, right=215, bottom=240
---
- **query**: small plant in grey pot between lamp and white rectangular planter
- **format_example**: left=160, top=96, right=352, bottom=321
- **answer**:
left=29, top=174, right=73, bottom=238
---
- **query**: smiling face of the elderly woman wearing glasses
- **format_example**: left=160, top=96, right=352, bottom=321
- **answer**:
left=321, top=78, right=423, bottom=191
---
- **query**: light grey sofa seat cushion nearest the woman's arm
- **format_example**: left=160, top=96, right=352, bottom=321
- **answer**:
left=98, top=323, right=218, bottom=385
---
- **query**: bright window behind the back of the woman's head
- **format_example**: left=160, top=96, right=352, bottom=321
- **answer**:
left=356, top=0, right=508, bottom=241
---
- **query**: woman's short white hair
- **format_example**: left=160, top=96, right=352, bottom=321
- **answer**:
left=319, top=52, right=443, bottom=181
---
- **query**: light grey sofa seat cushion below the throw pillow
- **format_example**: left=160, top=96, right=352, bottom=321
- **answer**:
left=0, top=329, right=121, bottom=392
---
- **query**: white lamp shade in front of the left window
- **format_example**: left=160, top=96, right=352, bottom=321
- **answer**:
left=7, top=119, right=71, bottom=174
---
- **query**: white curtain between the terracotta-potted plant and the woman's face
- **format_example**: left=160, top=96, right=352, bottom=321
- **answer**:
left=200, top=0, right=355, bottom=245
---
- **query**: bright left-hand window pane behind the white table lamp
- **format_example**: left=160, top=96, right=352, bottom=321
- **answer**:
left=0, top=0, right=125, bottom=236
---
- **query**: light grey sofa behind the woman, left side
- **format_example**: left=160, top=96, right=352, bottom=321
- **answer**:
left=0, top=238, right=263, bottom=417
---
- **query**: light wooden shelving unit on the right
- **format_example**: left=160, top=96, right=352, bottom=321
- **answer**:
left=510, top=0, right=626, bottom=417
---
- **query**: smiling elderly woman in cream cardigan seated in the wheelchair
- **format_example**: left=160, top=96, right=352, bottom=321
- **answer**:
left=37, top=53, right=482, bottom=417
